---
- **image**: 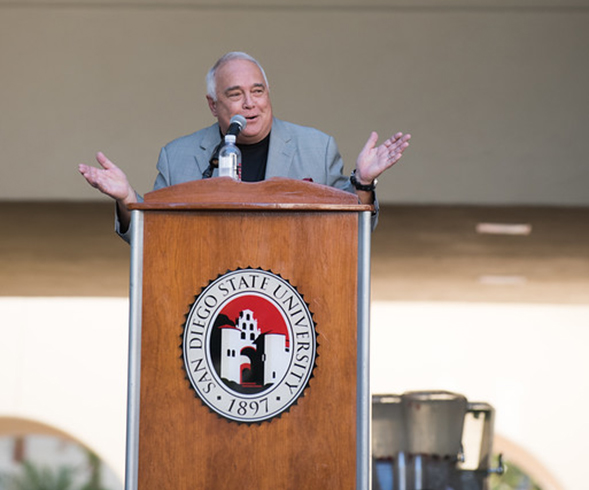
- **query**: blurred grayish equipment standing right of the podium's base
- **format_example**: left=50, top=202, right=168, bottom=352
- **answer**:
left=372, top=391, right=503, bottom=490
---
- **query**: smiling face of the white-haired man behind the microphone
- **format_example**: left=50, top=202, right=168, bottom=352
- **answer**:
left=207, top=59, right=272, bottom=144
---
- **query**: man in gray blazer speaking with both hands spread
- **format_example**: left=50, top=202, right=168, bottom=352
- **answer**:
left=79, top=52, right=411, bottom=238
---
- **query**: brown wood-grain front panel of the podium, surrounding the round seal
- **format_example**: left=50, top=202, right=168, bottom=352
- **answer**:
left=132, top=179, right=368, bottom=490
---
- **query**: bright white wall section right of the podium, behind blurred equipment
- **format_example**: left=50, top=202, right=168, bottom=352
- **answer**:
left=371, top=302, right=589, bottom=490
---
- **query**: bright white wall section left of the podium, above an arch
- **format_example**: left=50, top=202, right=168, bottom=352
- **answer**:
left=0, top=297, right=129, bottom=482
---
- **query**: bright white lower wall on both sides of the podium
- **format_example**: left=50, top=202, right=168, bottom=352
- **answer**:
left=0, top=298, right=589, bottom=490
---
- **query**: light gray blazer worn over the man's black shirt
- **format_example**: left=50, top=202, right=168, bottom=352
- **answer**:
left=115, top=118, right=378, bottom=242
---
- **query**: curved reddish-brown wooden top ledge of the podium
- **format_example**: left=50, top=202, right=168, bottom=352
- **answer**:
left=129, top=177, right=372, bottom=212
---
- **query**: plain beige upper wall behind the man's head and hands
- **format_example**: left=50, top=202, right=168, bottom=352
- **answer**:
left=0, top=0, right=589, bottom=205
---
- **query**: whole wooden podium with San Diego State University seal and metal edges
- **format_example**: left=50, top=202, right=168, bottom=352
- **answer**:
left=125, top=178, right=372, bottom=490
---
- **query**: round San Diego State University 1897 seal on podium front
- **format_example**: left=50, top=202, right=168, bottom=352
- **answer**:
left=182, top=269, right=317, bottom=423
